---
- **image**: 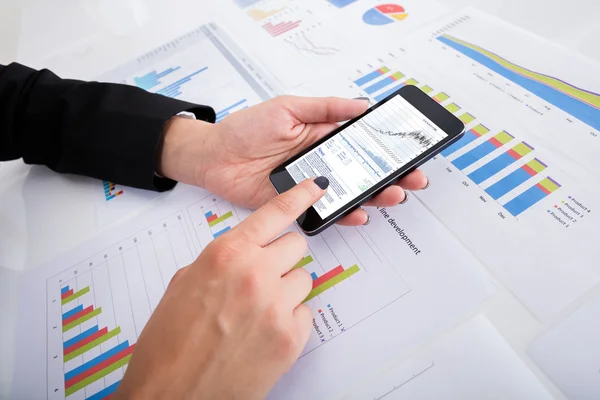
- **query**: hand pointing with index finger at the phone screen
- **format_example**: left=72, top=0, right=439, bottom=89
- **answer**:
left=114, top=178, right=328, bottom=399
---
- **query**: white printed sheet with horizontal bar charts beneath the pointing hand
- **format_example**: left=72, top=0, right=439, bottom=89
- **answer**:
left=14, top=185, right=496, bottom=399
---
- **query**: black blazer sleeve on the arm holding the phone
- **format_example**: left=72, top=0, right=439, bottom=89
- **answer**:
left=0, top=63, right=215, bottom=191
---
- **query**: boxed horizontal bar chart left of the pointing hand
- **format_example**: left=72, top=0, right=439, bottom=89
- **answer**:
left=47, top=214, right=197, bottom=400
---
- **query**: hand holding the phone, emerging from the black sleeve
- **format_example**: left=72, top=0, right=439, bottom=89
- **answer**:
left=162, top=96, right=428, bottom=225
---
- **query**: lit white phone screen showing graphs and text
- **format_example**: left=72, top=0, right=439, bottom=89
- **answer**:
left=286, top=95, right=447, bottom=219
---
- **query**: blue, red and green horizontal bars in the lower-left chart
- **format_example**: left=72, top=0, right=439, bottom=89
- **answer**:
left=61, top=285, right=135, bottom=399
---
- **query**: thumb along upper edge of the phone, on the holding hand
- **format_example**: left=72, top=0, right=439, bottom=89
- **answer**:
left=280, top=96, right=369, bottom=123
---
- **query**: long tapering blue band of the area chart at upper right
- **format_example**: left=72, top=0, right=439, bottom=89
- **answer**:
left=437, top=36, right=600, bottom=129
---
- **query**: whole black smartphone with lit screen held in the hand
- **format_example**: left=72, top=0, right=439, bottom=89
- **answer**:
left=270, top=85, right=465, bottom=236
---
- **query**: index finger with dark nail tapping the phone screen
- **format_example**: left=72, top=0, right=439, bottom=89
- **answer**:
left=232, top=176, right=329, bottom=246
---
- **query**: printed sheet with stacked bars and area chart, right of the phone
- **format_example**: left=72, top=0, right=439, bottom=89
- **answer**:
left=298, top=9, right=600, bottom=319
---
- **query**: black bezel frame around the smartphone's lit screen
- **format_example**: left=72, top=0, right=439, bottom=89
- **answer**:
left=269, top=85, right=465, bottom=236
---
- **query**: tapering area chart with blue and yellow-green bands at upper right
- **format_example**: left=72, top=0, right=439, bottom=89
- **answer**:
left=437, top=35, right=600, bottom=129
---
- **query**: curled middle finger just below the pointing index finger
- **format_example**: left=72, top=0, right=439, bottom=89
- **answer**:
left=266, top=232, right=308, bottom=276
